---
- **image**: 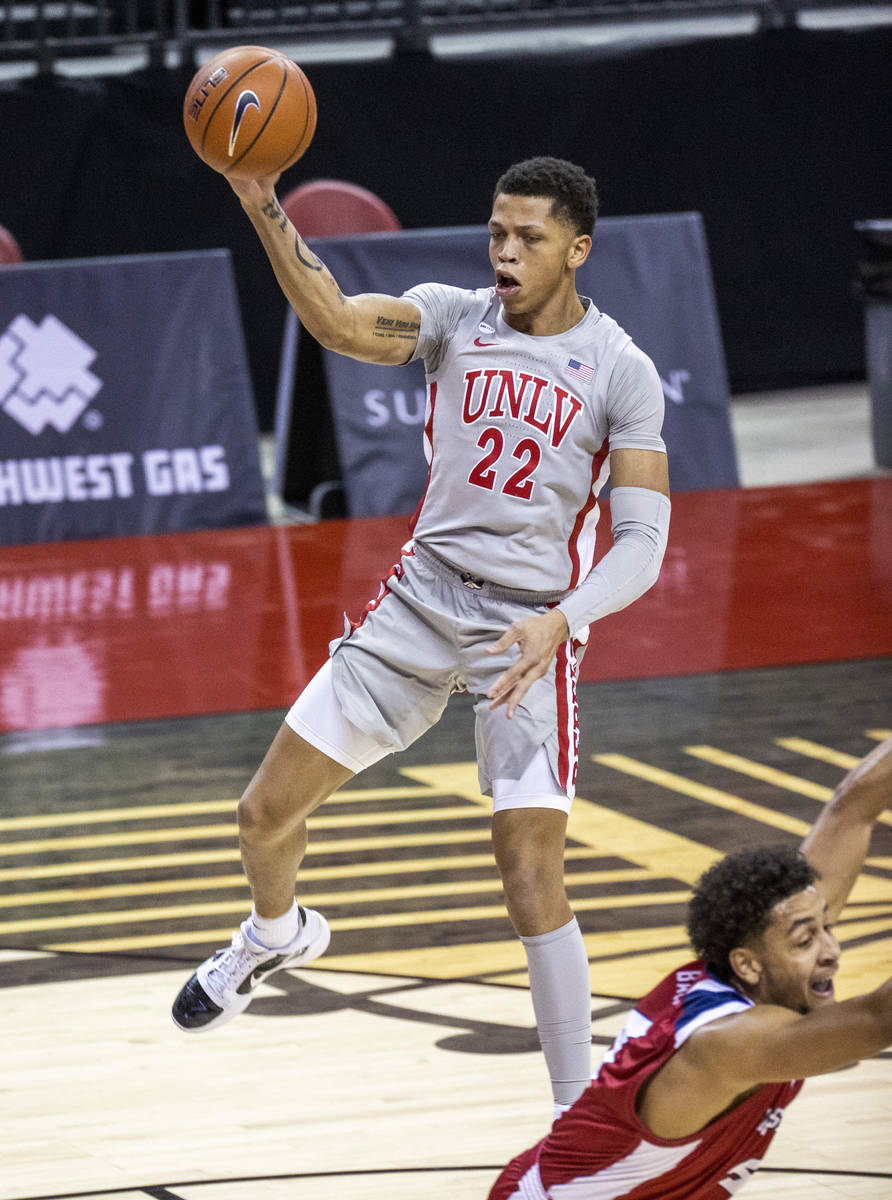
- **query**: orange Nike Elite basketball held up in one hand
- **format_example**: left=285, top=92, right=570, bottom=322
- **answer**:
left=182, top=46, right=316, bottom=179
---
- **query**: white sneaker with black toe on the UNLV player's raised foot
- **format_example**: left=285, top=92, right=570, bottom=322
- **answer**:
left=172, top=907, right=331, bottom=1033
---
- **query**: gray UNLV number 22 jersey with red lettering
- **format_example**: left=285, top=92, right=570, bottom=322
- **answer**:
left=405, top=283, right=665, bottom=593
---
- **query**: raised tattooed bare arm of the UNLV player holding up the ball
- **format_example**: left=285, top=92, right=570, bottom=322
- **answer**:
left=229, top=175, right=420, bottom=365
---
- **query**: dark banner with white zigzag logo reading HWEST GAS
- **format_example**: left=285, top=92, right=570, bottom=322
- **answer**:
left=0, top=251, right=265, bottom=545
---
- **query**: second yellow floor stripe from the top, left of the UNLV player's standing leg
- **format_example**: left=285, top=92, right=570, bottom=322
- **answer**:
left=0, top=804, right=481, bottom=857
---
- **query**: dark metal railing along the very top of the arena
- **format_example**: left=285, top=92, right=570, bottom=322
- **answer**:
left=0, top=0, right=890, bottom=71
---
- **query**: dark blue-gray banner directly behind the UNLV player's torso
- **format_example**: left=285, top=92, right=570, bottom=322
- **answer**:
left=280, top=212, right=738, bottom=516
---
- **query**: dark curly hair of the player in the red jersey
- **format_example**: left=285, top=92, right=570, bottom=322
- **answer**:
left=688, top=846, right=819, bottom=983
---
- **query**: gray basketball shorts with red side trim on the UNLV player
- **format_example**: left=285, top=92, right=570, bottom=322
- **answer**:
left=286, top=544, right=579, bottom=811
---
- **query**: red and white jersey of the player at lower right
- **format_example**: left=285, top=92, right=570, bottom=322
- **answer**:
left=490, top=962, right=802, bottom=1200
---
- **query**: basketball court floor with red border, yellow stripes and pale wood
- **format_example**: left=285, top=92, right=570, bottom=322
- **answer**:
left=0, top=479, right=892, bottom=1200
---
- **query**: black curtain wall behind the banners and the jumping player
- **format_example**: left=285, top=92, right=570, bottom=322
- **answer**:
left=0, top=19, right=892, bottom=417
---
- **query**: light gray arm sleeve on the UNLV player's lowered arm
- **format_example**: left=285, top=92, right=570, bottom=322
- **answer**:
left=557, top=487, right=671, bottom=637
